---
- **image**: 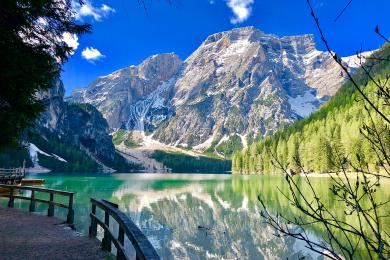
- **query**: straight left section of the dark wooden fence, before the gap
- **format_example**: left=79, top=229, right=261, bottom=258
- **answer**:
left=0, top=184, right=74, bottom=227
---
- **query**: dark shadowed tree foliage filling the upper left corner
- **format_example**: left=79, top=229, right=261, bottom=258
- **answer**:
left=0, top=0, right=90, bottom=149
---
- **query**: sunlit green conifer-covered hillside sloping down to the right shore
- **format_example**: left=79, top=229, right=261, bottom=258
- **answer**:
left=233, top=44, right=390, bottom=174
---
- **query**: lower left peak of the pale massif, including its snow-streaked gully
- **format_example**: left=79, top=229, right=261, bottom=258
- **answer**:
left=72, top=54, right=182, bottom=130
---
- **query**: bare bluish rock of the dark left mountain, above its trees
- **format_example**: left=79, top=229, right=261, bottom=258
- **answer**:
left=37, top=81, right=115, bottom=160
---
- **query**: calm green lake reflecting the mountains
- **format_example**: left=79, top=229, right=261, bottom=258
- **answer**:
left=2, top=174, right=390, bottom=259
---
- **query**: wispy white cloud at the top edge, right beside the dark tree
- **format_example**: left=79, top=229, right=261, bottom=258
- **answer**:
left=72, top=0, right=116, bottom=21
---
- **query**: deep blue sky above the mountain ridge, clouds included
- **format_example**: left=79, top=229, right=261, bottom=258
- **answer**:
left=61, top=0, right=390, bottom=95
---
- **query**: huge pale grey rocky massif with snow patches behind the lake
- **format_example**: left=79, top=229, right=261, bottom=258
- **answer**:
left=71, top=27, right=360, bottom=155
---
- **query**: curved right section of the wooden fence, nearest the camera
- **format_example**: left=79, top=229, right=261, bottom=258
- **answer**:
left=89, top=198, right=160, bottom=260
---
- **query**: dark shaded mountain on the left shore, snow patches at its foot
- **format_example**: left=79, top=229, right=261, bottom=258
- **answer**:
left=0, top=80, right=136, bottom=172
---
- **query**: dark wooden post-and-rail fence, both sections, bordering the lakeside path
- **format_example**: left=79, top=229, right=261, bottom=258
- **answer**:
left=0, top=184, right=160, bottom=260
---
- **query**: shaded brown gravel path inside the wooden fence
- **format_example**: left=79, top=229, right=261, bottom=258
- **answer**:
left=0, top=207, right=106, bottom=260
